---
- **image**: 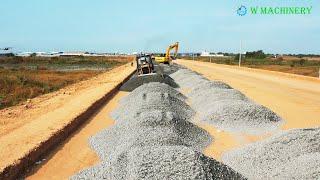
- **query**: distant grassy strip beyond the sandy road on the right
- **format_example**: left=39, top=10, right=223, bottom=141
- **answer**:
left=183, top=57, right=320, bottom=77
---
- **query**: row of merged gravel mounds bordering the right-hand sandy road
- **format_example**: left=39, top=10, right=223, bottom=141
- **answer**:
left=171, top=69, right=283, bottom=134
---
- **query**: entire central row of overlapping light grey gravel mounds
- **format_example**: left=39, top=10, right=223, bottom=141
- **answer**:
left=71, top=83, right=244, bottom=180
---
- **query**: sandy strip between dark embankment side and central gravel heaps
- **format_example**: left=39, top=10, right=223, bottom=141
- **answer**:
left=27, top=92, right=128, bottom=179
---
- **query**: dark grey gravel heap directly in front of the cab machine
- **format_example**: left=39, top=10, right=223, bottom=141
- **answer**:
left=120, top=73, right=178, bottom=92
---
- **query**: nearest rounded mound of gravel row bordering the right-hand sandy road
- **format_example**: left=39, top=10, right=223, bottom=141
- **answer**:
left=199, top=100, right=282, bottom=135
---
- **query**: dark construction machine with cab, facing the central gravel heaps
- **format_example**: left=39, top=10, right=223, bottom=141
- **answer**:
left=136, top=54, right=154, bottom=76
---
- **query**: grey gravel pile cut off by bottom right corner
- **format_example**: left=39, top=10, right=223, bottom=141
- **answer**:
left=222, top=128, right=320, bottom=180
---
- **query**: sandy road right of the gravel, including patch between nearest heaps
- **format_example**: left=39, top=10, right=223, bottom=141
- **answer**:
left=176, top=60, right=320, bottom=159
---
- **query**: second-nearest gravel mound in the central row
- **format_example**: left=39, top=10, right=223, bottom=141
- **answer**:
left=90, top=110, right=212, bottom=160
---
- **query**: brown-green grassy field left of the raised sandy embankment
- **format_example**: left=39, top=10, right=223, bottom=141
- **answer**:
left=0, top=57, right=131, bottom=109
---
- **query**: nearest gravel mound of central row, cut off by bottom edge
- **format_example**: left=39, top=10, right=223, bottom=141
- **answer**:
left=72, top=146, right=244, bottom=180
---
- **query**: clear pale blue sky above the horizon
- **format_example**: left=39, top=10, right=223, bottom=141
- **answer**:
left=0, top=0, right=320, bottom=54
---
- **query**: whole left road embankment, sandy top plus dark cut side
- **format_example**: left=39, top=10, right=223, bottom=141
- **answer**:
left=0, top=64, right=135, bottom=179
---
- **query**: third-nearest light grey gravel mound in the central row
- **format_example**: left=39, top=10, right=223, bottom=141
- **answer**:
left=111, top=83, right=195, bottom=121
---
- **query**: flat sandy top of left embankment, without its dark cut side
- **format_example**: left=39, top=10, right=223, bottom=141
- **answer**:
left=0, top=64, right=135, bottom=172
